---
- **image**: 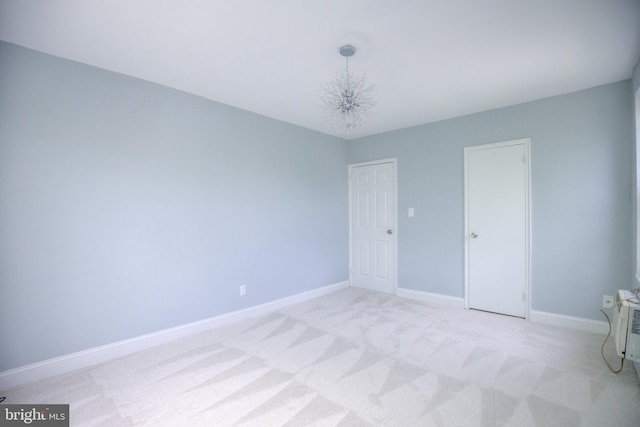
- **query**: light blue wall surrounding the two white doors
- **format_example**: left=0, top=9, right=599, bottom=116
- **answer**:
left=349, top=81, right=634, bottom=320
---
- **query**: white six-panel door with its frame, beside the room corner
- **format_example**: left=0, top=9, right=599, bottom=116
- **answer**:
left=349, top=159, right=397, bottom=293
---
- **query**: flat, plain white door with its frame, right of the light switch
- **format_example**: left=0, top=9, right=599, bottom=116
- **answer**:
left=464, top=139, right=529, bottom=317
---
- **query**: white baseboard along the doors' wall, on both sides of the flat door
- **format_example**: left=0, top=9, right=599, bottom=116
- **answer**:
left=396, top=288, right=609, bottom=335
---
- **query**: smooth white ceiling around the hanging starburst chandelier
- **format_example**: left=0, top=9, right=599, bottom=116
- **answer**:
left=0, top=0, right=640, bottom=139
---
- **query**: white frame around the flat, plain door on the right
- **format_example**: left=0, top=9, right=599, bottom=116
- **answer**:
left=464, top=138, right=531, bottom=319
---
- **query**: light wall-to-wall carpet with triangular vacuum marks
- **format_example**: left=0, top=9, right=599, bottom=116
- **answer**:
left=0, top=289, right=640, bottom=427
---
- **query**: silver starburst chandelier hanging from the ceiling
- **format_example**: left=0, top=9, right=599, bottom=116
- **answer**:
left=321, top=45, right=376, bottom=134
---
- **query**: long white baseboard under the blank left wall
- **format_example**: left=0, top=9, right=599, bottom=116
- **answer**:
left=0, top=281, right=349, bottom=390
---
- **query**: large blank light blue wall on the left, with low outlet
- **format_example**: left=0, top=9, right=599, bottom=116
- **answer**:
left=0, top=43, right=348, bottom=371
